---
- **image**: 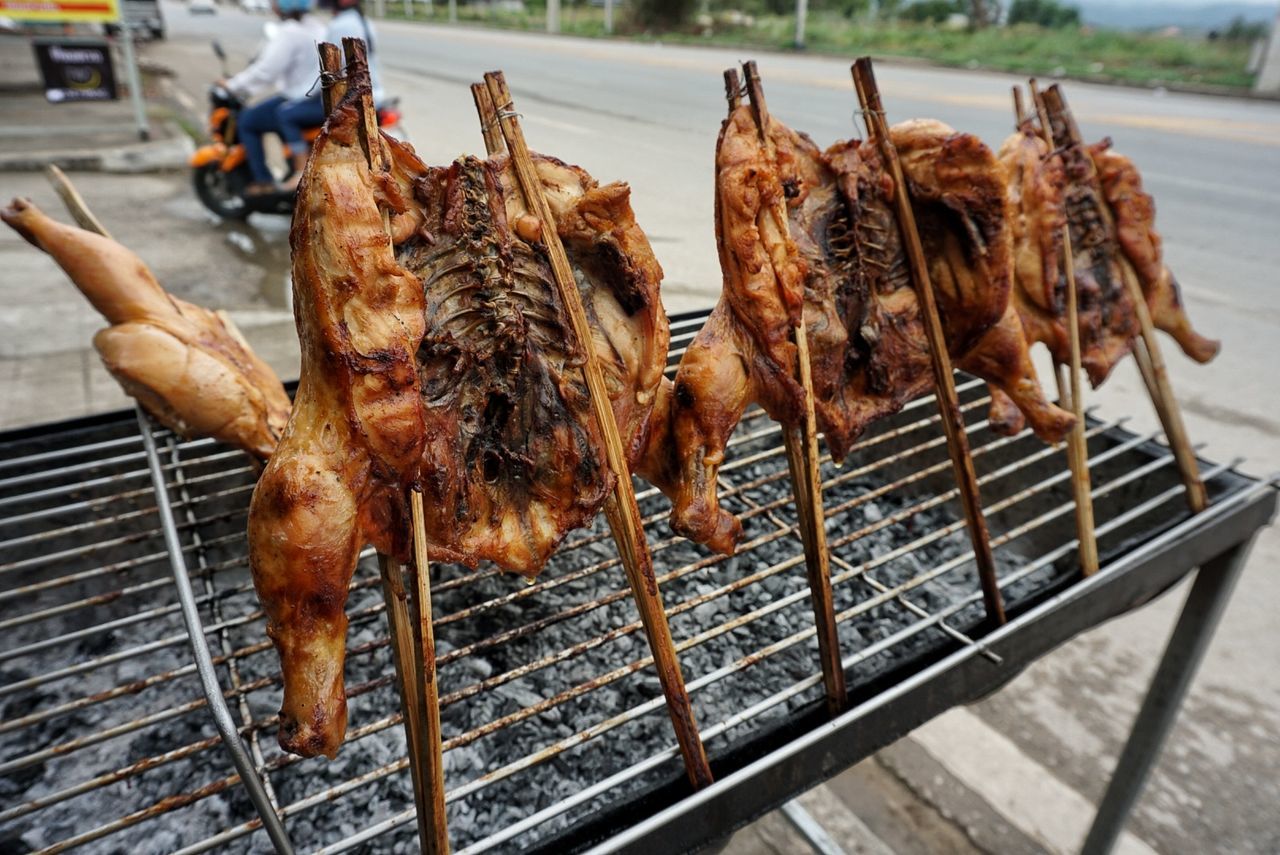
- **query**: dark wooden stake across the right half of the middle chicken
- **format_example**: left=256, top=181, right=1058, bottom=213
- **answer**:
left=852, top=56, right=1005, bottom=625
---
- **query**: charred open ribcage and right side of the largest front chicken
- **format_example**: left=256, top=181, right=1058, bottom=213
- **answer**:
left=409, top=155, right=669, bottom=576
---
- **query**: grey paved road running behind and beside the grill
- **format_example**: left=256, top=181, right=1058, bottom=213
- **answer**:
left=155, top=4, right=1280, bottom=852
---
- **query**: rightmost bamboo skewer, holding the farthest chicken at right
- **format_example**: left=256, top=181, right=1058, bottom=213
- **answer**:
left=1042, top=83, right=1208, bottom=513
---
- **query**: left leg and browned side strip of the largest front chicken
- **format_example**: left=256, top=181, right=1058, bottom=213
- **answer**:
left=248, top=100, right=426, bottom=756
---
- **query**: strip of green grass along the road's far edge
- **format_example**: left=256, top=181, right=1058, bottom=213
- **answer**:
left=387, top=0, right=1252, bottom=90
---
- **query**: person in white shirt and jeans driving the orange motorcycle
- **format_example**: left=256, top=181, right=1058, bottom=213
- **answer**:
left=225, top=0, right=324, bottom=193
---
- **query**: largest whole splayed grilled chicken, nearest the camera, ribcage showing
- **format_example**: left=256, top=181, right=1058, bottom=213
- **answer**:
left=250, top=87, right=668, bottom=756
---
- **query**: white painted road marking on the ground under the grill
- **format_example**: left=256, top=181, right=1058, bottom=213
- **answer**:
left=911, top=708, right=1156, bottom=855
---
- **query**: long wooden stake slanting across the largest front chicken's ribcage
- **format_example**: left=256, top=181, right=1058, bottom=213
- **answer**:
left=481, top=72, right=712, bottom=788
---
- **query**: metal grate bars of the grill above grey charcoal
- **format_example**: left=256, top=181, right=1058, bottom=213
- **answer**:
left=0, top=332, right=1259, bottom=852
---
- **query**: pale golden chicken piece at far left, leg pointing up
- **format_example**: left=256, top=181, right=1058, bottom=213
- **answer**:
left=0, top=198, right=289, bottom=459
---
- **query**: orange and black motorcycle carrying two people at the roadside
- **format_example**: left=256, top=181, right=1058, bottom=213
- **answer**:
left=189, top=41, right=404, bottom=220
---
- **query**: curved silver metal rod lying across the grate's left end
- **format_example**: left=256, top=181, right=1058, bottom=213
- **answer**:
left=137, top=407, right=293, bottom=855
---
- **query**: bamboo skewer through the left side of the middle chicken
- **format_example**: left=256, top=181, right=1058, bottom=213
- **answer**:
left=724, top=61, right=849, bottom=717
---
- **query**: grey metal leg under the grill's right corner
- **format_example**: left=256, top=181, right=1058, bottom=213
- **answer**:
left=1082, top=539, right=1253, bottom=855
